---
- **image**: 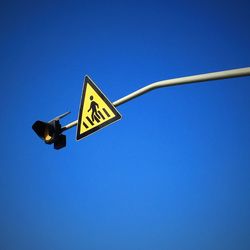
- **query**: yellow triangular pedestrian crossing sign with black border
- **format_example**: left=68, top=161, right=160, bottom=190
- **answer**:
left=76, top=76, right=121, bottom=140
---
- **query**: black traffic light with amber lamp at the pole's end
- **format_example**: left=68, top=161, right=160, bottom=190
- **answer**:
left=32, top=112, right=70, bottom=149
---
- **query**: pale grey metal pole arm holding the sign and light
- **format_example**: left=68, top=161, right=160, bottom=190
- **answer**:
left=62, top=67, right=250, bottom=131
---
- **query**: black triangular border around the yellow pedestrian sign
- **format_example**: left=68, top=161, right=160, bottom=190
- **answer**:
left=76, top=75, right=122, bottom=141
